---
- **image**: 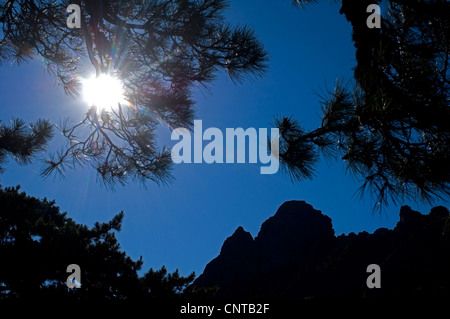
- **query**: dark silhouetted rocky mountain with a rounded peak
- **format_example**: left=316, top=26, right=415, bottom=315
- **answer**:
left=194, top=201, right=450, bottom=299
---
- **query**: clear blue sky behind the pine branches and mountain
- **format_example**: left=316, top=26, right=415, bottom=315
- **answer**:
left=0, top=0, right=448, bottom=275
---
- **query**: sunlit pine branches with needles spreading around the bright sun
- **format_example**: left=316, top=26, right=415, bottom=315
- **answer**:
left=0, top=0, right=267, bottom=185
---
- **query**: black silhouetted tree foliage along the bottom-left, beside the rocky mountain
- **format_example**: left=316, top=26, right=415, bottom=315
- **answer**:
left=0, top=187, right=212, bottom=301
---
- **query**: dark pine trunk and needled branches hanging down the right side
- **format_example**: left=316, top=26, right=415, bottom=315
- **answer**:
left=284, top=0, right=450, bottom=207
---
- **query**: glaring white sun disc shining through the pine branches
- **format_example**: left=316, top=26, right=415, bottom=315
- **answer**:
left=83, top=74, right=125, bottom=109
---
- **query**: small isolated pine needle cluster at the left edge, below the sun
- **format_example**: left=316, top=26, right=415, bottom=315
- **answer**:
left=0, top=119, right=53, bottom=172
